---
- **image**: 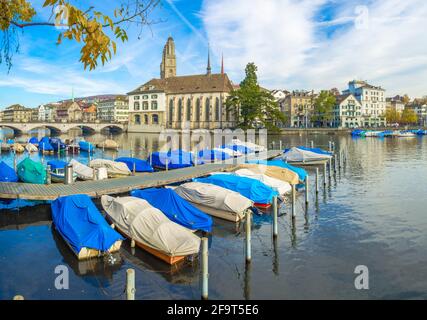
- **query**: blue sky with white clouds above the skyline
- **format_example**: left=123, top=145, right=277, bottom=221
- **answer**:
left=0, top=0, right=427, bottom=109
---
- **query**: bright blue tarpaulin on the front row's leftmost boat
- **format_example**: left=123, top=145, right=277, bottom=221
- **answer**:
left=51, top=194, right=124, bottom=253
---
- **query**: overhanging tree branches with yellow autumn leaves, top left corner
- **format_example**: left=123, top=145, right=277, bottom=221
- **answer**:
left=0, top=0, right=160, bottom=70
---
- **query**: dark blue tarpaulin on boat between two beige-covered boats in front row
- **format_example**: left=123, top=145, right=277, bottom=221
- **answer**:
left=130, top=188, right=212, bottom=232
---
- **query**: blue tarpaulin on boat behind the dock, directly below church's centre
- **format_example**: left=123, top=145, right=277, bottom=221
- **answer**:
left=147, top=150, right=203, bottom=170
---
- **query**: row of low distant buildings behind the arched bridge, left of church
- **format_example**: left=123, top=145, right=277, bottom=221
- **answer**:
left=0, top=95, right=129, bottom=123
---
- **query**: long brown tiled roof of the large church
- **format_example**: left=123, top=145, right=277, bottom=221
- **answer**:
left=128, top=73, right=233, bottom=95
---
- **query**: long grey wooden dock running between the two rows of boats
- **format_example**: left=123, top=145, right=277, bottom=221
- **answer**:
left=0, top=150, right=282, bottom=200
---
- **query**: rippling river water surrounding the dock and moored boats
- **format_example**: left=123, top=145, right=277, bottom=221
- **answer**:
left=0, top=129, right=427, bottom=299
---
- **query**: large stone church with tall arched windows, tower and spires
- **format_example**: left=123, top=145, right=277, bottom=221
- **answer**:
left=128, top=37, right=235, bottom=132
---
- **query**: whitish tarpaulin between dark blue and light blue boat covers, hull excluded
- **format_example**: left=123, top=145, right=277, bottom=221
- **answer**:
left=174, top=182, right=253, bottom=218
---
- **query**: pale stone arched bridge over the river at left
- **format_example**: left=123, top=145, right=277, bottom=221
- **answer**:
left=0, top=122, right=127, bottom=134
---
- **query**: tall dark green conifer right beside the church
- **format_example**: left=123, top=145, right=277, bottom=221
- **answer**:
left=226, top=63, right=286, bottom=131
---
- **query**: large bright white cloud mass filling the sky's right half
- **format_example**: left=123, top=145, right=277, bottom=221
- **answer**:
left=202, top=0, right=427, bottom=96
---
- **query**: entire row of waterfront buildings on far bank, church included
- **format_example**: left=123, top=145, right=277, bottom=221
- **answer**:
left=0, top=37, right=427, bottom=132
